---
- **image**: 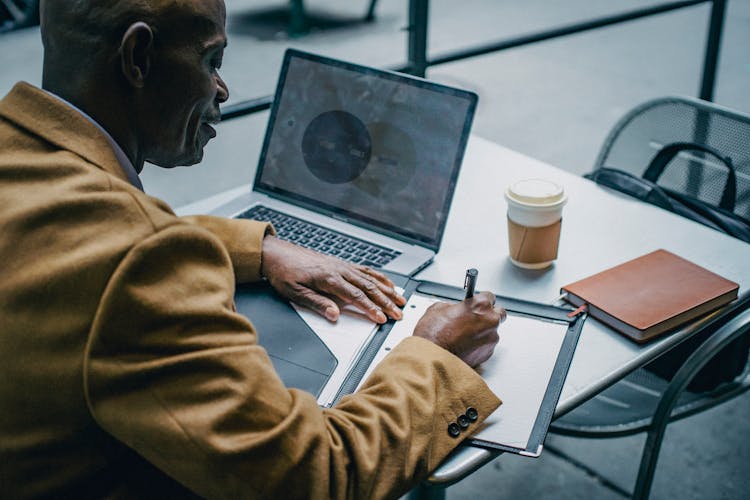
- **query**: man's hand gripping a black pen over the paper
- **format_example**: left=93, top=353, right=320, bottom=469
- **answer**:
left=414, top=292, right=505, bottom=366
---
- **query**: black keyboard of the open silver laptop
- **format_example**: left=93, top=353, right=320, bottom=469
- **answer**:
left=237, top=205, right=401, bottom=268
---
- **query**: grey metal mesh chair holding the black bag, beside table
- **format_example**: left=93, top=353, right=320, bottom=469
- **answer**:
left=550, top=97, right=750, bottom=498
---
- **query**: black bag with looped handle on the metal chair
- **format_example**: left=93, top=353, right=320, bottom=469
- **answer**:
left=585, top=142, right=750, bottom=392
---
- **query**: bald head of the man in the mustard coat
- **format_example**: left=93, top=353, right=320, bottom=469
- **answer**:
left=40, top=0, right=227, bottom=169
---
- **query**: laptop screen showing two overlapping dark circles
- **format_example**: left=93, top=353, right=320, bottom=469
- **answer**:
left=255, top=49, right=477, bottom=251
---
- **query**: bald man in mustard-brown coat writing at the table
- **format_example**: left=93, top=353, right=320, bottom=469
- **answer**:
left=0, top=0, right=504, bottom=498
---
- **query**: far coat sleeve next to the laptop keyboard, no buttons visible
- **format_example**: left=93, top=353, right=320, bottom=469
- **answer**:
left=181, top=215, right=276, bottom=283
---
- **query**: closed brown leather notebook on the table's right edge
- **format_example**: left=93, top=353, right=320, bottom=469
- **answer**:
left=561, top=250, right=739, bottom=343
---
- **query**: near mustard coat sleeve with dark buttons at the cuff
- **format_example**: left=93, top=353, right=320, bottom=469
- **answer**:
left=84, top=224, right=499, bottom=498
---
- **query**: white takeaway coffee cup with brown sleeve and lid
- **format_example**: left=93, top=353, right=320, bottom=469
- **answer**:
left=505, top=179, right=568, bottom=269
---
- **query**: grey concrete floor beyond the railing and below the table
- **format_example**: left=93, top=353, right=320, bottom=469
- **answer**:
left=0, top=0, right=750, bottom=500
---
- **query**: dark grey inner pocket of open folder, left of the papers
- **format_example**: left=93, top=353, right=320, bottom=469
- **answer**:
left=234, top=283, right=338, bottom=397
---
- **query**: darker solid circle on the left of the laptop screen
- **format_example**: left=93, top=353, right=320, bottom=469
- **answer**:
left=302, top=110, right=372, bottom=184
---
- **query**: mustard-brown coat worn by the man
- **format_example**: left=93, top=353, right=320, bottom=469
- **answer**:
left=0, top=83, right=506, bottom=498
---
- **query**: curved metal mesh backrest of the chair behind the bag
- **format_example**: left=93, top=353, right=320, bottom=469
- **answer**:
left=594, top=96, right=750, bottom=220
